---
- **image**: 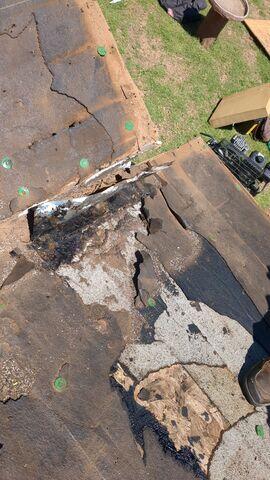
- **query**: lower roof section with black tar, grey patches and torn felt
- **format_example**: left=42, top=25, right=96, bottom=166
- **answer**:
left=0, top=139, right=270, bottom=480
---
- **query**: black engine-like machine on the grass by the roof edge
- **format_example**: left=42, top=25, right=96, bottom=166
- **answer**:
left=202, top=133, right=270, bottom=195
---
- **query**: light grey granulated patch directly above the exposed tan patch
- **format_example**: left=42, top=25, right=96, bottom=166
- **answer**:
left=120, top=284, right=266, bottom=380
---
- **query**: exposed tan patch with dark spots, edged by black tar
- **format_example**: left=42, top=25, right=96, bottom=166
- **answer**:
left=134, top=365, right=229, bottom=472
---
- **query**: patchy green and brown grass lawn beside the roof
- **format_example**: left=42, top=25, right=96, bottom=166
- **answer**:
left=100, top=0, right=270, bottom=208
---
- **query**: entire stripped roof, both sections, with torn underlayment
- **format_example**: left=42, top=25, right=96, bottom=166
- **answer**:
left=0, top=0, right=270, bottom=480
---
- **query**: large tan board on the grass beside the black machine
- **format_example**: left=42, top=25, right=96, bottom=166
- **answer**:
left=209, top=83, right=270, bottom=128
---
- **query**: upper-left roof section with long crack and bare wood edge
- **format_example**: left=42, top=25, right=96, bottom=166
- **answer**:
left=0, top=0, right=157, bottom=219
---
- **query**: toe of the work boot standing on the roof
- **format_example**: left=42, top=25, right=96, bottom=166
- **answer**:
left=241, top=358, right=270, bottom=406
